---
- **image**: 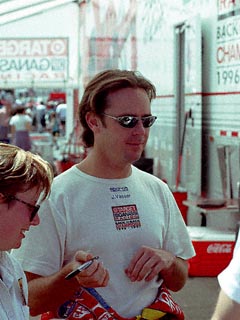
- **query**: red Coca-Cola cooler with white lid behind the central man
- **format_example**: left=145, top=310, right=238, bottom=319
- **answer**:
left=187, top=226, right=236, bottom=277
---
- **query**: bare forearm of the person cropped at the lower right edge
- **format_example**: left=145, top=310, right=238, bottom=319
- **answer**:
left=211, top=290, right=240, bottom=320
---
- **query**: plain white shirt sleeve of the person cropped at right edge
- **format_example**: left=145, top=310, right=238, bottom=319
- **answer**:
left=218, top=237, right=240, bottom=303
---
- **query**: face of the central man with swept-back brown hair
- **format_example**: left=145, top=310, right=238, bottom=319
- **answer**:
left=94, top=88, right=151, bottom=166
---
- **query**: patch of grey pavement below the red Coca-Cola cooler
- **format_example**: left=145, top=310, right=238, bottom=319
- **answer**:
left=173, top=277, right=219, bottom=320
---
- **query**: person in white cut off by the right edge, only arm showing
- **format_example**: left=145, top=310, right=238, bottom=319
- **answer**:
left=212, top=232, right=240, bottom=320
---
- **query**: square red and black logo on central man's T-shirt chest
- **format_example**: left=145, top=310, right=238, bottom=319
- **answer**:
left=112, top=204, right=141, bottom=230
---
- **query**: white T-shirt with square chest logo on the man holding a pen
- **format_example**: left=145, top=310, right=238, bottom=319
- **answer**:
left=11, top=166, right=194, bottom=317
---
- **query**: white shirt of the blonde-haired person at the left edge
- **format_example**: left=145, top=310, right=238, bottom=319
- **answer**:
left=0, top=251, right=29, bottom=320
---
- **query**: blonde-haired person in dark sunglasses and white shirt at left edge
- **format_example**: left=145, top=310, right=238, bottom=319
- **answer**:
left=0, top=143, right=53, bottom=320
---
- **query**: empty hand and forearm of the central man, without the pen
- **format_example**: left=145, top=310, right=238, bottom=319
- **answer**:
left=125, top=246, right=188, bottom=291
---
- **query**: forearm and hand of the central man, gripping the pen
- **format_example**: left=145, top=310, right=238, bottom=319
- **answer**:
left=25, top=251, right=109, bottom=316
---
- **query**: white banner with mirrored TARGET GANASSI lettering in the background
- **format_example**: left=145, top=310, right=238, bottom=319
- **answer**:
left=0, top=38, right=68, bottom=81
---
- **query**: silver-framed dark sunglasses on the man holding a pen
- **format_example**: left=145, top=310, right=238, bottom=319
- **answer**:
left=102, top=113, right=157, bottom=128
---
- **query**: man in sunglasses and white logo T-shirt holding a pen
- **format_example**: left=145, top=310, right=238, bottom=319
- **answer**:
left=11, top=70, right=194, bottom=318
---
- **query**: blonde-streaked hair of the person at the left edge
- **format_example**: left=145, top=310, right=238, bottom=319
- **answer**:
left=0, top=143, right=53, bottom=200
